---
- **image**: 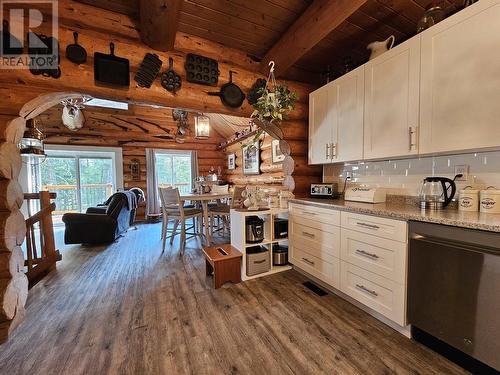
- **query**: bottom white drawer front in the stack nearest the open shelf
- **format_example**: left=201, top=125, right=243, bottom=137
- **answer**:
left=291, top=246, right=340, bottom=289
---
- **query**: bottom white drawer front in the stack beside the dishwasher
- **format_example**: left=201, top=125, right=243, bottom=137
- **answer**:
left=340, top=261, right=406, bottom=326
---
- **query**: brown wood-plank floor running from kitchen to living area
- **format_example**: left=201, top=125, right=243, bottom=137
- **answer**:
left=0, top=224, right=465, bottom=375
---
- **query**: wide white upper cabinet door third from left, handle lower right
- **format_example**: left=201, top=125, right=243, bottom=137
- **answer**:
left=364, top=36, right=420, bottom=159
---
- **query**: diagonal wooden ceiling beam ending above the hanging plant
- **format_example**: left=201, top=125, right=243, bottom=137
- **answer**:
left=260, top=0, right=366, bottom=76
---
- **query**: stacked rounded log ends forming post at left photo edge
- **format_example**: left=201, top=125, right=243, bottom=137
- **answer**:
left=0, top=116, right=28, bottom=343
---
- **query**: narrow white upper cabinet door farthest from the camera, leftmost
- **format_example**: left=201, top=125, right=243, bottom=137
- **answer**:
left=309, top=85, right=332, bottom=164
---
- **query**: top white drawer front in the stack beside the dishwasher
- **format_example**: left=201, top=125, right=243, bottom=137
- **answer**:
left=341, top=212, right=408, bottom=243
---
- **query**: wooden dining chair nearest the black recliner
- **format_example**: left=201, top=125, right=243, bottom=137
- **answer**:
left=158, top=188, right=203, bottom=255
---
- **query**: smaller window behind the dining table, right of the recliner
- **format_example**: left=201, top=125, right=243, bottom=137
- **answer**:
left=155, top=150, right=193, bottom=194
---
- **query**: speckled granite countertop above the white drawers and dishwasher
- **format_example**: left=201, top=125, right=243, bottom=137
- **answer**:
left=290, top=198, right=500, bottom=232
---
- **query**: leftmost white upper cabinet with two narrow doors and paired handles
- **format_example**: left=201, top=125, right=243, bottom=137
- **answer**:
left=309, top=66, right=364, bottom=164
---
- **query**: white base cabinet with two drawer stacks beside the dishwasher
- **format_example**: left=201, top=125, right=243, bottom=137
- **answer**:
left=289, top=202, right=408, bottom=326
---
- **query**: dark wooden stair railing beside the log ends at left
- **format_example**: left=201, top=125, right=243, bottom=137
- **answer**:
left=24, top=191, right=62, bottom=285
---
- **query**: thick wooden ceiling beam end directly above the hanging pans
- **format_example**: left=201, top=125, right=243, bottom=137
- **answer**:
left=139, top=0, right=182, bottom=51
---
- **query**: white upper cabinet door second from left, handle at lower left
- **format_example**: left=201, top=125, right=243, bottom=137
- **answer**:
left=332, top=66, right=365, bottom=162
